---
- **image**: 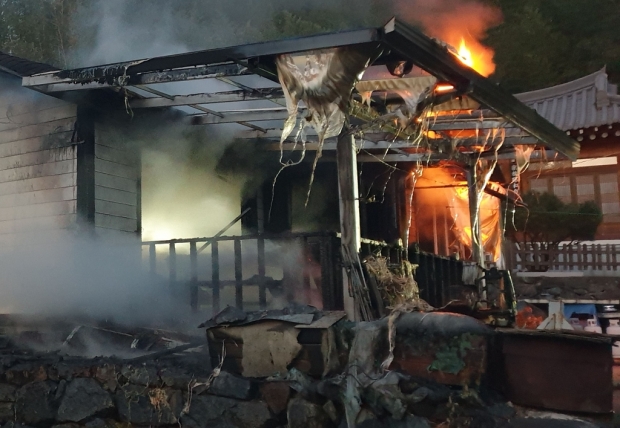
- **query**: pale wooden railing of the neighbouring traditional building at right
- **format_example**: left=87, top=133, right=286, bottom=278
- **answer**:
left=506, top=242, right=620, bottom=274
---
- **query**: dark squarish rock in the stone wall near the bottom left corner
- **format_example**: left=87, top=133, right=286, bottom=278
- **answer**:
left=15, top=381, right=56, bottom=425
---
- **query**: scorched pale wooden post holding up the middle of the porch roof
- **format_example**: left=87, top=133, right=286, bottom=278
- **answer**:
left=336, top=130, right=361, bottom=320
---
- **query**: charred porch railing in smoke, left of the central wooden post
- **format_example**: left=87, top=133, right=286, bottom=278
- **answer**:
left=142, top=232, right=343, bottom=312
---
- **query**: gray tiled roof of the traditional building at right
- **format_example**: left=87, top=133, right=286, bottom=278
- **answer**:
left=515, top=68, right=620, bottom=131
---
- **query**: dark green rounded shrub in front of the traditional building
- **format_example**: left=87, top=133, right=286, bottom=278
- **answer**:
left=506, top=192, right=603, bottom=248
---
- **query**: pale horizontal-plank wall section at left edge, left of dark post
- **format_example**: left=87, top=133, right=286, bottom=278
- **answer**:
left=0, top=81, right=77, bottom=237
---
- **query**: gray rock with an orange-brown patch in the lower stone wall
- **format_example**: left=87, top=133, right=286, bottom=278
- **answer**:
left=115, top=385, right=183, bottom=426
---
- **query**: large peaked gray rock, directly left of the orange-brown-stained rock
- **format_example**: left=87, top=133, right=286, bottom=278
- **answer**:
left=57, top=378, right=114, bottom=422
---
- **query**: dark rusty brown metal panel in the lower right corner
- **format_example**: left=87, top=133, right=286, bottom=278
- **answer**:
left=502, top=331, right=614, bottom=413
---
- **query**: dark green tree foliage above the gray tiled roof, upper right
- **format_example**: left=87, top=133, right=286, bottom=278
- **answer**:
left=485, top=0, right=620, bottom=93
